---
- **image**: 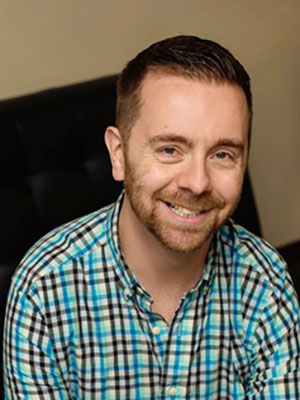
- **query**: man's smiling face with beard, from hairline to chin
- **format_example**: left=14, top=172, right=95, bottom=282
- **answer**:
left=110, top=74, right=248, bottom=253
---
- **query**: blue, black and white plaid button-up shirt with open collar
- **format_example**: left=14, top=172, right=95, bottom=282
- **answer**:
left=4, top=194, right=300, bottom=400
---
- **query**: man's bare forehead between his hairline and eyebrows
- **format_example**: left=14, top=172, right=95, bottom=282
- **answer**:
left=133, top=72, right=249, bottom=144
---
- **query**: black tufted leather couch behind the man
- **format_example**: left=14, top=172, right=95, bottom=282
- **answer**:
left=0, top=76, right=300, bottom=398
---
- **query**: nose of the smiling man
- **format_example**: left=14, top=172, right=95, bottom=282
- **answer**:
left=177, top=157, right=212, bottom=195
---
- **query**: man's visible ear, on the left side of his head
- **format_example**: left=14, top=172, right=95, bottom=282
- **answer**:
left=104, top=126, right=124, bottom=181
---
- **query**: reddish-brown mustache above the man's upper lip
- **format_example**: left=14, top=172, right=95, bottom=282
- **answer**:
left=155, top=191, right=225, bottom=211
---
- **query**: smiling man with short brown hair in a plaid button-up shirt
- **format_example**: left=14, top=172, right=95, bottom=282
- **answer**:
left=5, top=36, right=300, bottom=400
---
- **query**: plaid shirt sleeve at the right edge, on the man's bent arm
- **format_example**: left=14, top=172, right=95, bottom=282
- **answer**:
left=247, top=274, right=300, bottom=400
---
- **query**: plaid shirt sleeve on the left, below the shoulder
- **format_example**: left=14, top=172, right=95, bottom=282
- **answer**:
left=4, top=285, right=69, bottom=400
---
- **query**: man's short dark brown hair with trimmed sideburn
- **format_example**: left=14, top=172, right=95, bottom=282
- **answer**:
left=116, top=35, right=252, bottom=142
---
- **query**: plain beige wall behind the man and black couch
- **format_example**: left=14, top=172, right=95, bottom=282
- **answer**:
left=0, top=0, right=300, bottom=245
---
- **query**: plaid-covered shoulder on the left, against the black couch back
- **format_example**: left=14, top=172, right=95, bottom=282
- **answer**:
left=13, top=205, right=114, bottom=292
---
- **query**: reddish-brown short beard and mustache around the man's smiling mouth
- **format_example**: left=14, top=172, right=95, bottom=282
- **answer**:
left=124, top=157, right=239, bottom=253
